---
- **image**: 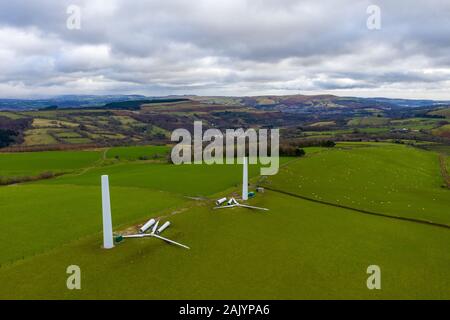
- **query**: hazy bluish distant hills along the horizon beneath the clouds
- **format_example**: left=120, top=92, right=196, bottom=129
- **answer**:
left=0, top=94, right=450, bottom=112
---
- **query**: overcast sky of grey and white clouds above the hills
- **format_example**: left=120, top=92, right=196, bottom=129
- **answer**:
left=0, top=0, right=450, bottom=100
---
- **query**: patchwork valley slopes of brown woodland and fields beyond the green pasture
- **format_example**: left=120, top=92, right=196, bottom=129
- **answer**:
left=0, top=95, right=450, bottom=150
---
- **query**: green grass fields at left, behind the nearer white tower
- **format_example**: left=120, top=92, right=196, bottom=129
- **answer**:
left=0, top=146, right=282, bottom=264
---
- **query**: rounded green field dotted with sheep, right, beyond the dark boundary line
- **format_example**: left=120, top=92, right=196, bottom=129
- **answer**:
left=264, top=144, right=450, bottom=225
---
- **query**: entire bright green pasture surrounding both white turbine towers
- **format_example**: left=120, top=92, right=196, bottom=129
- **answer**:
left=0, top=143, right=450, bottom=299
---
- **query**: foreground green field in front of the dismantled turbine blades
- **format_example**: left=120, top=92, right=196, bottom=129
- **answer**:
left=0, top=192, right=450, bottom=299
